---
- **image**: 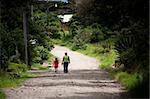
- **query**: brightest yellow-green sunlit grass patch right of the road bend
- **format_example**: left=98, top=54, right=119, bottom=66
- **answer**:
left=77, top=44, right=117, bottom=69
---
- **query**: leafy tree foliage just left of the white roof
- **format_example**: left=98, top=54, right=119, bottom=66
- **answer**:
left=33, top=10, right=61, bottom=38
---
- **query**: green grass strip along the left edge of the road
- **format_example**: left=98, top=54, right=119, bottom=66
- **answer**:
left=0, top=51, right=53, bottom=99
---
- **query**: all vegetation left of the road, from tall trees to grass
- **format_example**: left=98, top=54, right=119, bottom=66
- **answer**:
left=0, top=0, right=61, bottom=98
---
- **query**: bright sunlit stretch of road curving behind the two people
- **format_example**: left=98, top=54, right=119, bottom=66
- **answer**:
left=51, top=45, right=100, bottom=70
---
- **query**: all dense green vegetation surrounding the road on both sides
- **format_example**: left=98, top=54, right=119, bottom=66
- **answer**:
left=0, top=0, right=149, bottom=98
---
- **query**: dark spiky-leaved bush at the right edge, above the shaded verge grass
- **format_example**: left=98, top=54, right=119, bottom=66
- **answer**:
left=115, top=22, right=148, bottom=70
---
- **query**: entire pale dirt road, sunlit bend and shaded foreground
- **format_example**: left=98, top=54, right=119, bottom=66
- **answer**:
left=5, top=46, right=128, bottom=99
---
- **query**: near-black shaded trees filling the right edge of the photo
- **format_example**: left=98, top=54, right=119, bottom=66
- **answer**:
left=70, top=0, right=149, bottom=97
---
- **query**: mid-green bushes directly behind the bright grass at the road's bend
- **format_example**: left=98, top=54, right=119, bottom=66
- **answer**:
left=69, top=19, right=114, bottom=51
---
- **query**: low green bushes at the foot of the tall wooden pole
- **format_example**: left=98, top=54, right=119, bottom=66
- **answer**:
left=0, top=63, right=33, bottom=89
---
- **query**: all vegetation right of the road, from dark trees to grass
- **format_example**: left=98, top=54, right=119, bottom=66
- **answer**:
left=55, top=0, right=149, bottom=98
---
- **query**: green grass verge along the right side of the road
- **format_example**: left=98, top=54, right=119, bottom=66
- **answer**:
left=77, top=44, right=143, bottom=91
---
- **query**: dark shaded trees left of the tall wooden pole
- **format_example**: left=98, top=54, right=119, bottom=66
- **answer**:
left=0, top=0, right=28, bottom=70
